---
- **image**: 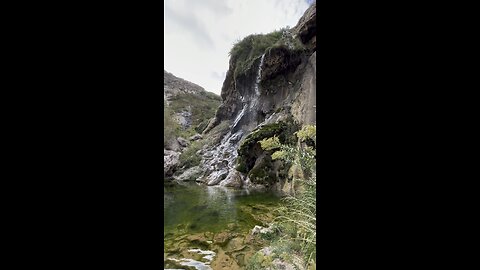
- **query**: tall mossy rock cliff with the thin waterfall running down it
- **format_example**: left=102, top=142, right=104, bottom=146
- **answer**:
left=202, top=3, right=316, bottom=190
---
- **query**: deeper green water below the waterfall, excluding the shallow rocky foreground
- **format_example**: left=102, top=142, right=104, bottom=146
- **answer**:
left=163, top=183, right=280, bottom=236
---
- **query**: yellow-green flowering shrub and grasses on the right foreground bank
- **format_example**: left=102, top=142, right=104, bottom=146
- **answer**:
left=260, top=126, right=316, bottom=264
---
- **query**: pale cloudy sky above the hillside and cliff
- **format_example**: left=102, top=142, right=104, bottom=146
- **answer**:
left=164, top=0, right=312, bottom=94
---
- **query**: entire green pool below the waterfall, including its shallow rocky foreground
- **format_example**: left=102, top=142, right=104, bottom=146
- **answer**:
left=163, top=183, right=280, bottom=270
